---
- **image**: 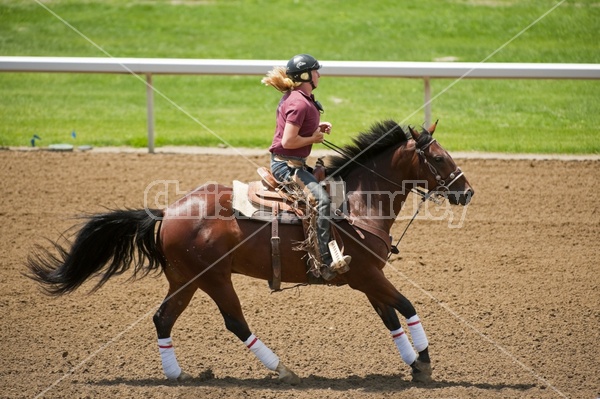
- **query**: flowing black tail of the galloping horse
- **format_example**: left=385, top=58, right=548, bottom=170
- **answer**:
left=27, top=209, right=166, bottom=296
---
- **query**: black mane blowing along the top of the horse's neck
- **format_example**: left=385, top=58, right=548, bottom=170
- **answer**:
left=327, top=119, right=431, bottom=177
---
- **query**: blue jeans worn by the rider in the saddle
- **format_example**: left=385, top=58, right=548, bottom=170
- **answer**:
left=271, top=156, right=333, bottom=266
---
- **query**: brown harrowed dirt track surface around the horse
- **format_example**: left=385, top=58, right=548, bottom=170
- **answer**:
left=0, top=151, right=600, bottom=398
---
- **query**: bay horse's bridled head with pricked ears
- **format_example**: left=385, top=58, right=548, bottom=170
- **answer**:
left=409, top=122, right=475, bottom=205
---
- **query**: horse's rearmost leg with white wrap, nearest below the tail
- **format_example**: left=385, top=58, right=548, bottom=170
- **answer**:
left=153, top=284, right=196, bottom=381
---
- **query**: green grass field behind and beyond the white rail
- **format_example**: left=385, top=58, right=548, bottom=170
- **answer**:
left=0, top=0, right=600, bottom=153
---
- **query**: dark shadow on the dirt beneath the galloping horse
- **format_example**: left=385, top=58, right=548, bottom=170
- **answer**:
left=96, top=370, right=537, bottom=392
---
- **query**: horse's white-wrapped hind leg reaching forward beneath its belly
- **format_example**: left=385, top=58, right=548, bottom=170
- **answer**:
left=200, top=276, right=300, bottom=385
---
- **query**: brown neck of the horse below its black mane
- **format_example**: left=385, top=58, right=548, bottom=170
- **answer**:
left=346, top=149, right=415, bottom=232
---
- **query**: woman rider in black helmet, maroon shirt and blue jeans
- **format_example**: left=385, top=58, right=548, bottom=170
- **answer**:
left=262, top=54, right=352, bottom=280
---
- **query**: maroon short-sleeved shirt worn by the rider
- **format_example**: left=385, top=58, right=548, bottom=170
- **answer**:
left=269, top=90, right=321, bottom=158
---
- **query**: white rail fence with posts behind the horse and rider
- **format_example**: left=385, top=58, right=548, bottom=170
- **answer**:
left=0, top=57, right=600, bottom=152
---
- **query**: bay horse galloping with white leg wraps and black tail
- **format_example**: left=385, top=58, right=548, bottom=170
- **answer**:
left=27, top=120, right=474, bottom=385
